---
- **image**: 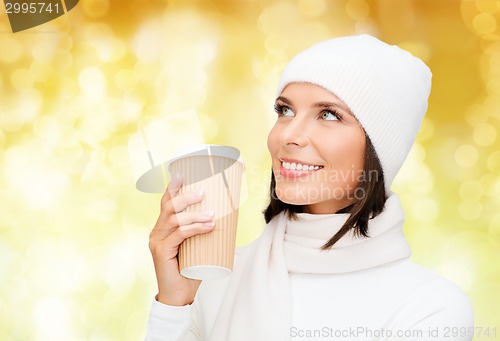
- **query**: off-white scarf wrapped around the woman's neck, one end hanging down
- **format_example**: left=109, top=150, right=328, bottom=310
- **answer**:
left=209, top=194, right=411, bottom=341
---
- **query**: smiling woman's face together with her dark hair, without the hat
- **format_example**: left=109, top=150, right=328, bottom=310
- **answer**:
left=264, top=83, right=386, bottom=249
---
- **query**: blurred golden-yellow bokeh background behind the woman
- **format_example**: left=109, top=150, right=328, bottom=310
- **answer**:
left=0, top=0, right=500, bottom=341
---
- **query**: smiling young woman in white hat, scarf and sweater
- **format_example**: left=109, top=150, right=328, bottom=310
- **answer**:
left=146, top=35, right=473, bottom=341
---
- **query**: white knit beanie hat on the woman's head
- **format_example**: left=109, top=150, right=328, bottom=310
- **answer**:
left=277, top=34, right=432, bottom=192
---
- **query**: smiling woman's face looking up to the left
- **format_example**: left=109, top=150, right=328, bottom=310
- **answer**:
left=267, top=83, right=365, bottom=214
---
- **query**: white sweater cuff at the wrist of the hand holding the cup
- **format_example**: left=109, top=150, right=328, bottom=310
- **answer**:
left=145, top=299, right=202, bottom=341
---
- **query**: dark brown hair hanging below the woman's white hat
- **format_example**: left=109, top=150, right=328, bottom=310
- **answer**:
left=263, top=135, right=387, bottom=250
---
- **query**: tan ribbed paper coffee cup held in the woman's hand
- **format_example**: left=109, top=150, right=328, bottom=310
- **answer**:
left=167, top=145, right=245, bottom=280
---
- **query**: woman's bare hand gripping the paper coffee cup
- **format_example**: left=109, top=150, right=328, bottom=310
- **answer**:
left=149, top=177, right=214, bottom=306
